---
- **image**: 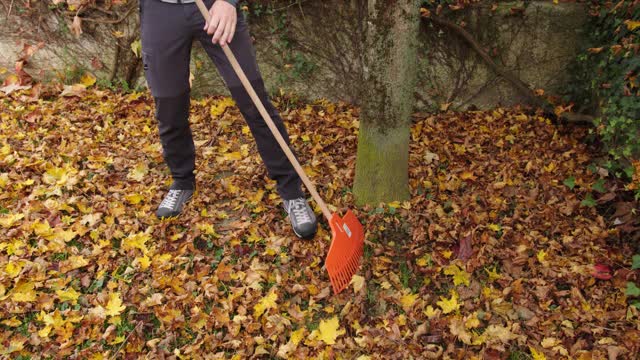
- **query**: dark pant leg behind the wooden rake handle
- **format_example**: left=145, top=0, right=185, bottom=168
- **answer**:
left=195, top=10, right=304, bottom=200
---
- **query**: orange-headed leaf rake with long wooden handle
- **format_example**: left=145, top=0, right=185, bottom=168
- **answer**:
left=196, top=0, right=364, bottom=294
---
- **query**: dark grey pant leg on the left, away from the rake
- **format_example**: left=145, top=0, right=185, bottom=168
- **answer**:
left=140, top=0, right=195, bottom=189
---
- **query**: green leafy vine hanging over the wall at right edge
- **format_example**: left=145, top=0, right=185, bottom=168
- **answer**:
left=569, top=0, right=640, bottom=194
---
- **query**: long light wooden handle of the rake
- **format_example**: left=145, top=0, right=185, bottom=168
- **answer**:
left=196, top=0, right=332, bottom=221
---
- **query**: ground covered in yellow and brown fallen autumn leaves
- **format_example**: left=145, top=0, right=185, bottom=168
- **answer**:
left=0, top=89, right=640, bottom=359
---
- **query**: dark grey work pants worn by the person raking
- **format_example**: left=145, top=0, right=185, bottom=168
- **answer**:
left=140, top=0, right=303, bottom=200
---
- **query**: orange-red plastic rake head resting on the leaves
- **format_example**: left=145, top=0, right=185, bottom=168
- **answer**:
left=325, top=210, right=364, bottom=294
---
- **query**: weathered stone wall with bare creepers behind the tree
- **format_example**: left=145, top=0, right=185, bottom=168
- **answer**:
left=0, top=0, right=587, bottom=110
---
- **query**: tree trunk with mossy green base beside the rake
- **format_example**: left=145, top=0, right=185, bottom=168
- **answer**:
left=354, top=0, right=420, bottom=204
